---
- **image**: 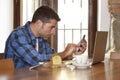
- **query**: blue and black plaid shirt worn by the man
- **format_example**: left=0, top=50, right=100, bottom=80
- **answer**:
left=5, top=22, right=54, bottom=68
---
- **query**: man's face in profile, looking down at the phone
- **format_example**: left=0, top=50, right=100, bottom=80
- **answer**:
left=39, top=19, right=57, bottom=38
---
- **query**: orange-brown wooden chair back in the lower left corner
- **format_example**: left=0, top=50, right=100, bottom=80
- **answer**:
left=0, top=58, right=14, bottom=74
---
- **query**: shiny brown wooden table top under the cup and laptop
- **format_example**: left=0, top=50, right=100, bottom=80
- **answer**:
left=1, top=59, right=120, bottom=80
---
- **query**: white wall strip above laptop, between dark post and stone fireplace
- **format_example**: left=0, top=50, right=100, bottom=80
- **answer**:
left=98, top=0, right=110, bottom=31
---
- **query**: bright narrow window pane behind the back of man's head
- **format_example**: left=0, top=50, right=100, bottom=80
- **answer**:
left=21, top=0, right=38, bottom=25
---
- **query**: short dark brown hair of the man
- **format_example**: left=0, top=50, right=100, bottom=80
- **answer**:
left=32, top=6, right=60, bottom=23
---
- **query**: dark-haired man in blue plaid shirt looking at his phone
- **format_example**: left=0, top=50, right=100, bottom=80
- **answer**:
left=5, top=6, right=86, bottom=68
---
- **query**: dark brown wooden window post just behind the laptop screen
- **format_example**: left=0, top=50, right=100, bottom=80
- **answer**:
left=88, top=0, right=98, bottom=57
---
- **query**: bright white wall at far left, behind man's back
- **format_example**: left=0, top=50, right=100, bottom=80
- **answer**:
left=0, top=0, right=13, bottom=53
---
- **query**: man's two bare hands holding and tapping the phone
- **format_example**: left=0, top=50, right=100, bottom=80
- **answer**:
left=55, top=39, right=87, bottom=59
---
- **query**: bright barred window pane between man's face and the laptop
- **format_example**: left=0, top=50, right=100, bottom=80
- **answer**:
left=58, top=0, right=88, bottom=52
